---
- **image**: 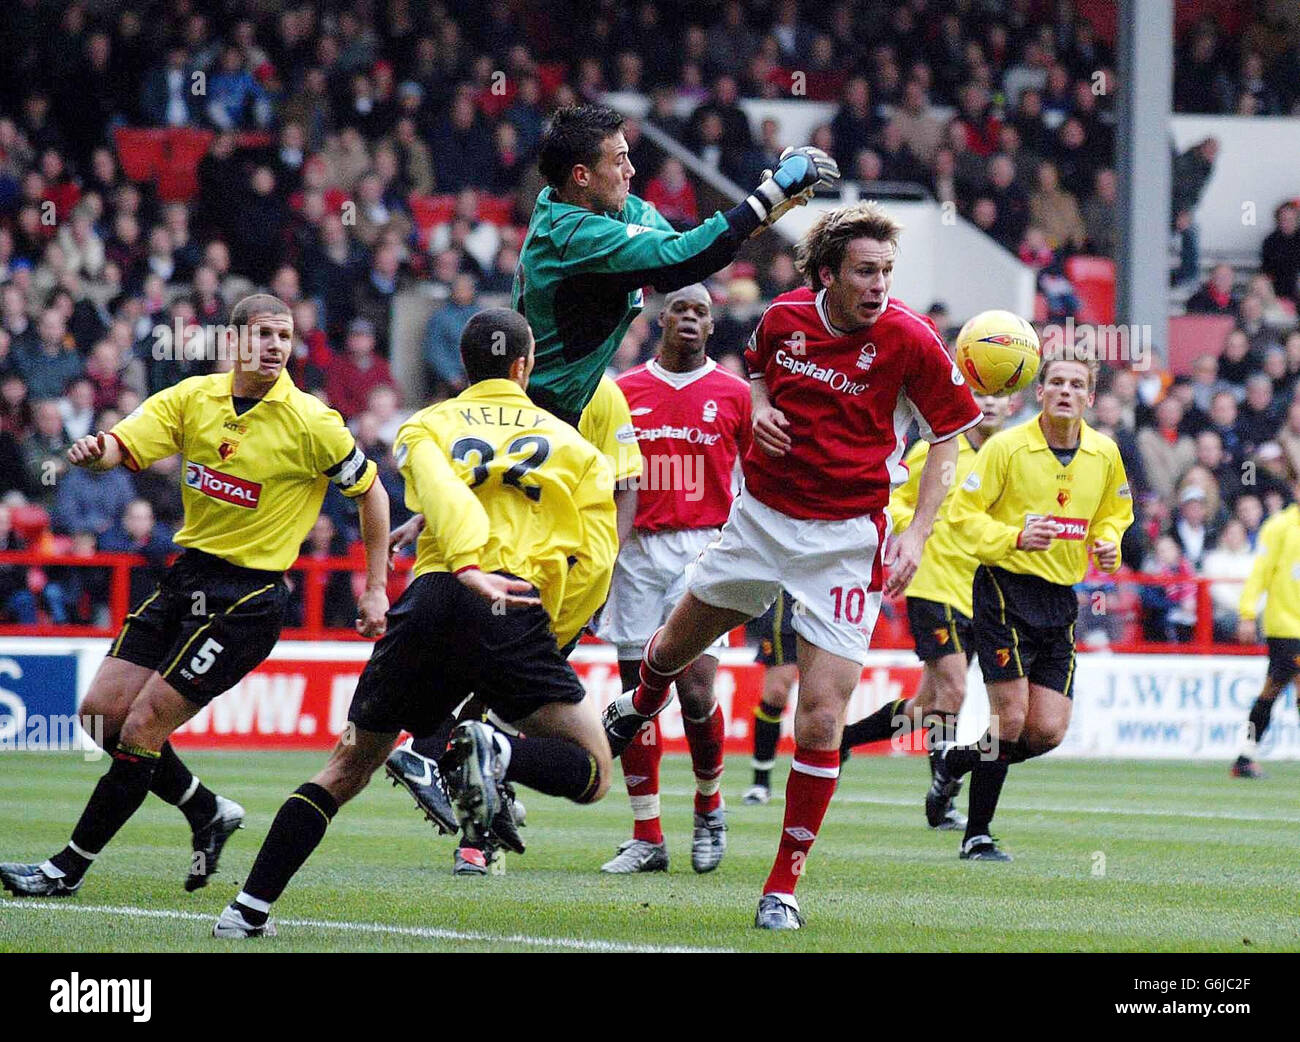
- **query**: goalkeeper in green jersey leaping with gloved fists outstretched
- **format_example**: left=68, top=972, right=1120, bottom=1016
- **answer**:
left=512, top=105, right=840, bottom=426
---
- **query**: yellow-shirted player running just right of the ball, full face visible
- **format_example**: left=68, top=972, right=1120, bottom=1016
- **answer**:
left=941, top=359, right=1134, bottom=861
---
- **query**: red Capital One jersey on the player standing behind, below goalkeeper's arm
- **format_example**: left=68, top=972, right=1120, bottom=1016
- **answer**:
left=618, top=359, right=750, bottom=531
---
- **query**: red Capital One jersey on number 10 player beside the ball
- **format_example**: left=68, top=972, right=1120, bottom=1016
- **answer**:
left=741, top=288, right=980, bottom=521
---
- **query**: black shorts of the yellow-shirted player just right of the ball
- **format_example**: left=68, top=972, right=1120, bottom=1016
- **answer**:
left=971, top=565, right=1078, bottom=698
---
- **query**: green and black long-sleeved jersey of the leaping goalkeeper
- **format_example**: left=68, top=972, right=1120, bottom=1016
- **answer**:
left=511, top=187, right=758, bottom=424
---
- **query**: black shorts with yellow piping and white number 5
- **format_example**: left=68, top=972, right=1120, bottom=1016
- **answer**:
left=108, top=550, right=289, bottom=705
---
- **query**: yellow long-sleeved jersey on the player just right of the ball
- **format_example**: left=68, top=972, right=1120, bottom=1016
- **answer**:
left=948, top=413, right=1134, bottom=586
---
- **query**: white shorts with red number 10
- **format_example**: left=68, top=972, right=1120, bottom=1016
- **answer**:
left=686, top=491, right=891, bottom=663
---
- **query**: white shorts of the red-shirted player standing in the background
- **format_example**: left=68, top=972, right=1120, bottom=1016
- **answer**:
left=595, top=529, right=727, bottom=661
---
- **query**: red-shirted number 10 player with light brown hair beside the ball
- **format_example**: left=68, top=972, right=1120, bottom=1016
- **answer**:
left=606, top=203, right=982, bottom=929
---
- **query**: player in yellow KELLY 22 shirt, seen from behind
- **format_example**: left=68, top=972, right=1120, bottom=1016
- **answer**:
left=213, top=308, right=618, bottom=938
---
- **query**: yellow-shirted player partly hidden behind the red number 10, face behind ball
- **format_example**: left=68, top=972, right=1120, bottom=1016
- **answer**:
left=840, top=395, right=1010, bottom=832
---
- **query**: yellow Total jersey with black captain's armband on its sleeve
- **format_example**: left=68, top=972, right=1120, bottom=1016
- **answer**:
left=109, top=372, right=378, bottom=572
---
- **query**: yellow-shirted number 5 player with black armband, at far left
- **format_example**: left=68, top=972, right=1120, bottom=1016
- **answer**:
left=0, top=294, right=389, bottom=896
